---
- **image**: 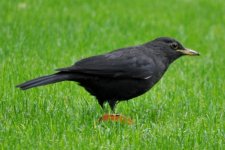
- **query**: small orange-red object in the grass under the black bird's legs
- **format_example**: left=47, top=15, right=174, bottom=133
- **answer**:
left=99, top=114, right=133, bottom=125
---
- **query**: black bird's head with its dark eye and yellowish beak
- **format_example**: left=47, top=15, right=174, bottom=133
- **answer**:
left=148, top=37, right=200, bottom=61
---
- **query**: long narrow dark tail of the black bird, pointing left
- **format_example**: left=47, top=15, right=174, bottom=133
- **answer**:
left=16, top=73, right=70, bottom=90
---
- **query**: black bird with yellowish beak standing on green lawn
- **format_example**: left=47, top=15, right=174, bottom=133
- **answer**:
left=17, top=37, right=199, bottom=110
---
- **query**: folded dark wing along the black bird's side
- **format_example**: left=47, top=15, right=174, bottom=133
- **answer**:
left=57, top=48, right=155, bottom=79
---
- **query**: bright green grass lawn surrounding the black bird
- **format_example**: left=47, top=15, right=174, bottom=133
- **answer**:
left=0, top=0, right=225, bottom=149
